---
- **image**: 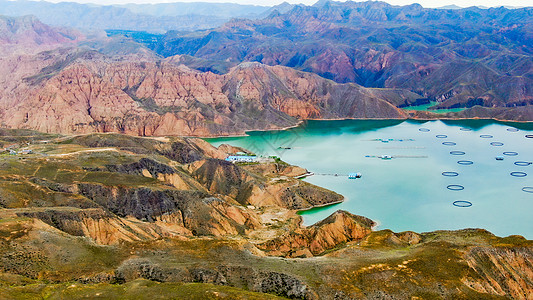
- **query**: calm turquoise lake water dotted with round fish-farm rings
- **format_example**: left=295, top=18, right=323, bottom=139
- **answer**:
left=209, top=120, right=533, bottom=239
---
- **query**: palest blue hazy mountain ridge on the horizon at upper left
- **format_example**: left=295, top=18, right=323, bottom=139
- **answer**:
left=0, top=0, right=269, bottom=33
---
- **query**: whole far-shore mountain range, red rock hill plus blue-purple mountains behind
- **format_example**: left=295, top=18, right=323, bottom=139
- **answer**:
left=0, top=2, right=533, bottom=136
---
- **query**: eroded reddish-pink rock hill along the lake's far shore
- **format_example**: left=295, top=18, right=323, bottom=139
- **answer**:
left=0, top=50, right=419, bottom=136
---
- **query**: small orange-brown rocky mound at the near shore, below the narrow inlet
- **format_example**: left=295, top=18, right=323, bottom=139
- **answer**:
left=258, top=211, right=375, bottom=257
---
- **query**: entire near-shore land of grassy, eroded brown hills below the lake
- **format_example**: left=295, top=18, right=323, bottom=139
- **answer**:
left=0, top=130, right=533, bottom=299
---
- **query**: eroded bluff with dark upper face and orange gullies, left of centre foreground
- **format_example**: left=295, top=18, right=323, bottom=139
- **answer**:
left=78, top=184, right=259, bottom=236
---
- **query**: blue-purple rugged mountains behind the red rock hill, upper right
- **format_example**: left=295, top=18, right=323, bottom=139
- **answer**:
left=141, top=1, right=533, bottom=107
